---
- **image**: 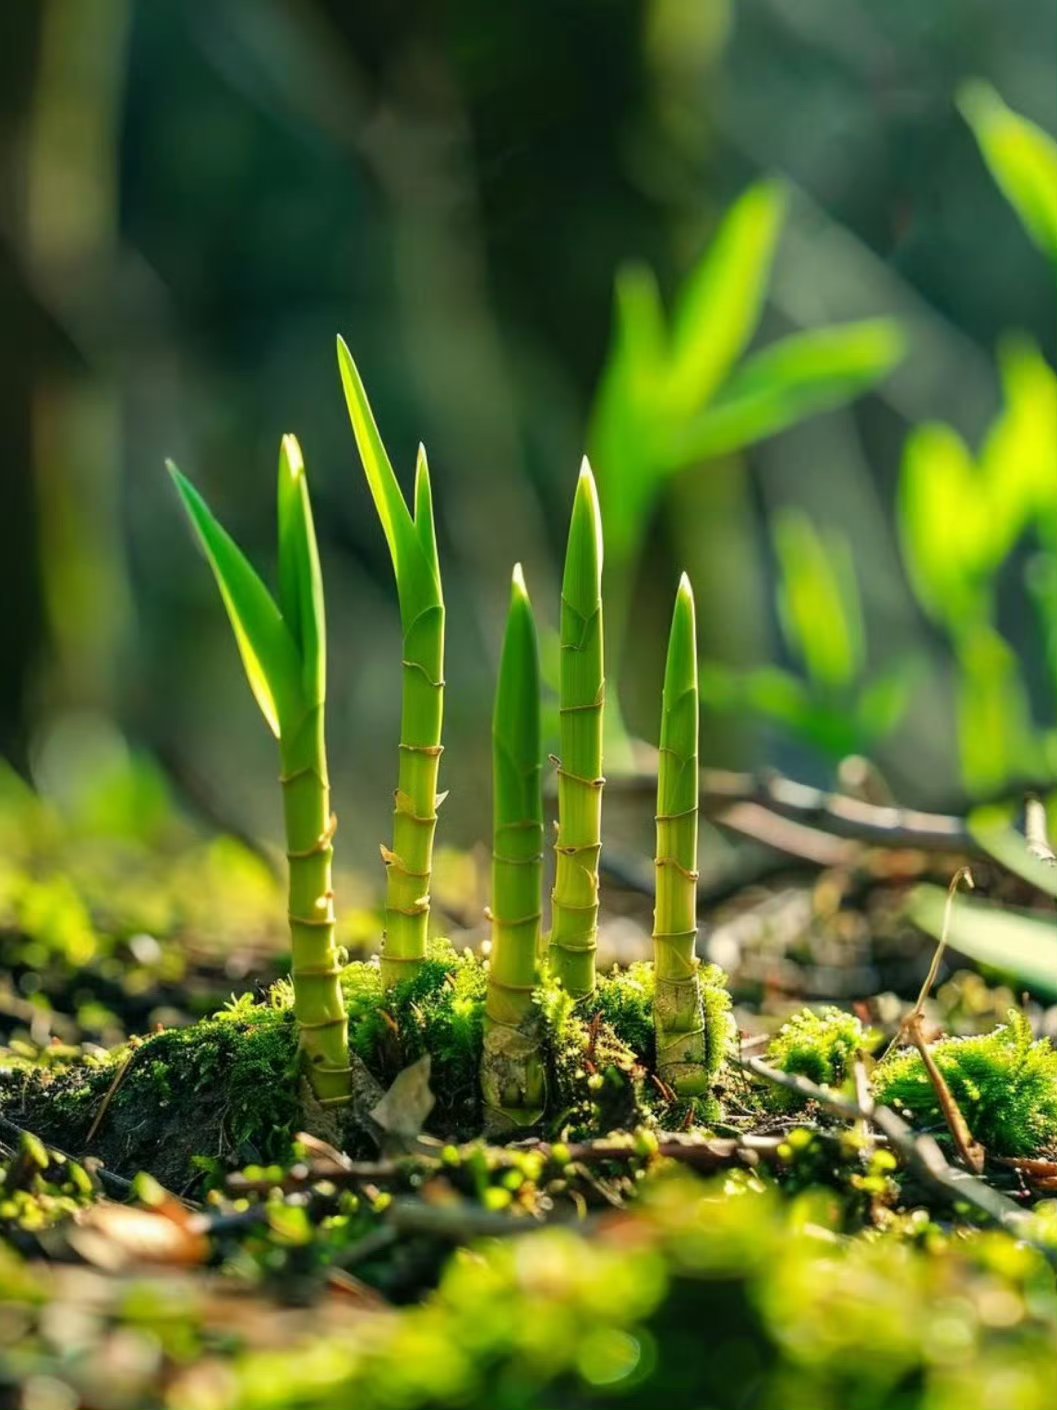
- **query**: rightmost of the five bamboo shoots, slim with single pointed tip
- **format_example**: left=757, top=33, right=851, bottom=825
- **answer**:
left=654, top=574, right=709, bottom=1097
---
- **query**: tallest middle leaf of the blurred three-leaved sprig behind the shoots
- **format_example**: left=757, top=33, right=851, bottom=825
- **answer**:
left=669, top=180, right=785, bottom=412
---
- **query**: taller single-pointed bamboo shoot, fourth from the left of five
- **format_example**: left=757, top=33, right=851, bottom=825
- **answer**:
left=550, top=458, right=605, bottom=998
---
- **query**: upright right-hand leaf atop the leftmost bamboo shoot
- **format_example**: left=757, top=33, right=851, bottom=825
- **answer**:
left=278, top=436, right=327, bottom=705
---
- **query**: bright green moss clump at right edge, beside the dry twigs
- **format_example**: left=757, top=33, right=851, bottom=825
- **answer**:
left=874, top=1010, right=1057, bottom=1155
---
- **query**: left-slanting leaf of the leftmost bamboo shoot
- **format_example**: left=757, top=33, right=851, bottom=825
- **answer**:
left=168, top=461, right=300, bottom=737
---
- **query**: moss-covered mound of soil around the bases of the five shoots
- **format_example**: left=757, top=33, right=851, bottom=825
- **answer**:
left=0, top=940, right=731, bottom=1190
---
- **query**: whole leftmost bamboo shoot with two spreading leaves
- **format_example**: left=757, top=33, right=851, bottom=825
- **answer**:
left=169, top=436, right=352, bottom=1107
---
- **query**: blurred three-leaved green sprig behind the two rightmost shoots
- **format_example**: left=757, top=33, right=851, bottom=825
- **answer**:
left=589, top=180, right=903, bottom=595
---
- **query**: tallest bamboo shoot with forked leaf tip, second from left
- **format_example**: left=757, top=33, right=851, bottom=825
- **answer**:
left=338, top=338, right=444, bottom=988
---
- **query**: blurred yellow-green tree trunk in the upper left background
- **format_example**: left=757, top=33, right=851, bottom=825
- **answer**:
left=18, top=0, right=131, bottom=738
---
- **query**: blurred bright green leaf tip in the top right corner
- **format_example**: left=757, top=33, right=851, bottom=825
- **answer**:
left=958, top=80, right=1057, bottom=259
